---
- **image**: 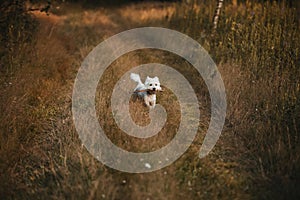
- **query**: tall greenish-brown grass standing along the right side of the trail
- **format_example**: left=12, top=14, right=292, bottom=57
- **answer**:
left=171, top=1, right=300, bottom=198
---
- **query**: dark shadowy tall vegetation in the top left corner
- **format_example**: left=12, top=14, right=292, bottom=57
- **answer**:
left=0, top=0, right=37, bottom=72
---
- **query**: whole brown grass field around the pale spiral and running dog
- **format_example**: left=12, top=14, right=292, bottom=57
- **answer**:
left=0, top=1, right=300, bottom=200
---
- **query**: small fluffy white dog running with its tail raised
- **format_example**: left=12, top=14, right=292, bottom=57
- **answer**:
left=130, top=73, right=162, bottom=108
